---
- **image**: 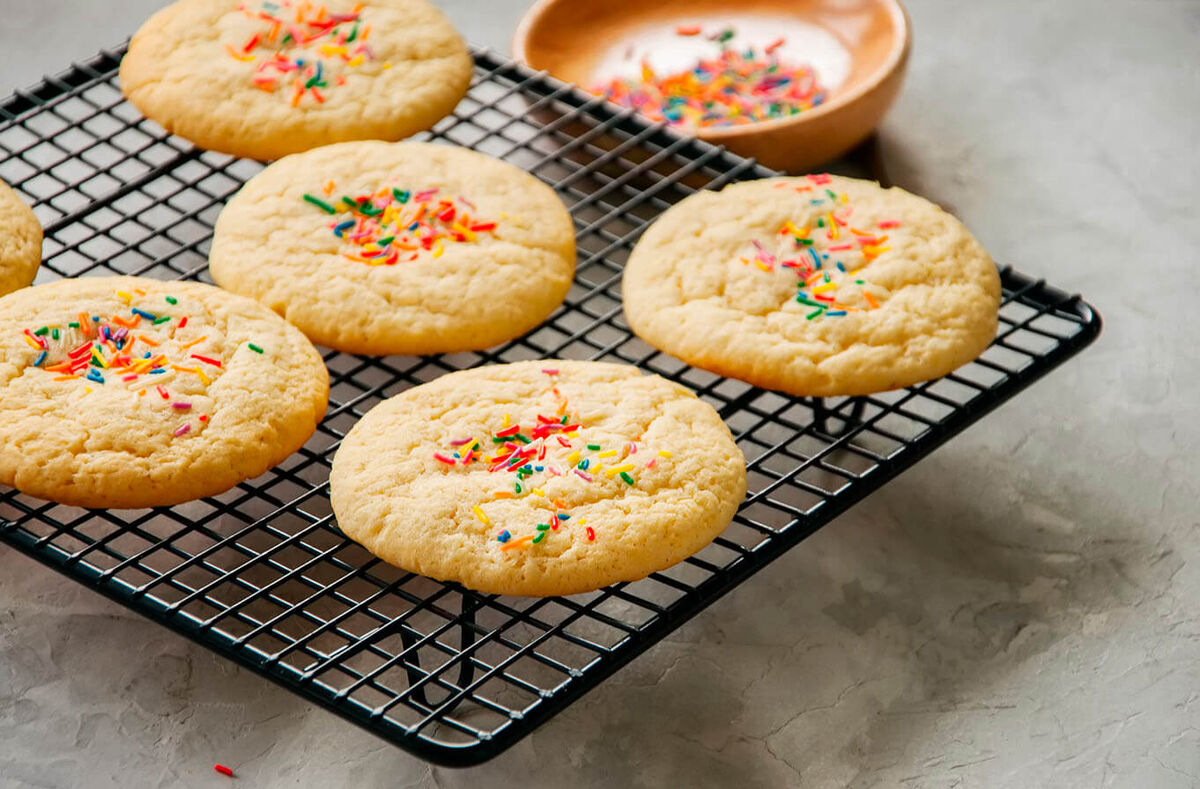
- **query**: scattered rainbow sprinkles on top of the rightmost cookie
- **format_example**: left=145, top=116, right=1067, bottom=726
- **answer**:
left=740, top=174, right=900, bottom=320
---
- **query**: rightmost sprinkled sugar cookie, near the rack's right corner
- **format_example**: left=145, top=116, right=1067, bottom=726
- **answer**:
left=623, top=175, right=1000, bottom=397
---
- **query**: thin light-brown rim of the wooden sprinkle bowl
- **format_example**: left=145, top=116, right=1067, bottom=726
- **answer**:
left=511, top=0, right=912, bottom=141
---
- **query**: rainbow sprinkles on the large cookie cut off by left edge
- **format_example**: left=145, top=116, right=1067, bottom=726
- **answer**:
left=23, top=290, right=263, bottom=436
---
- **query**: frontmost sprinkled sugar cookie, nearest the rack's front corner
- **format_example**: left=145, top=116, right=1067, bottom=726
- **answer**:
left=330, top=361, right=746, bottom=596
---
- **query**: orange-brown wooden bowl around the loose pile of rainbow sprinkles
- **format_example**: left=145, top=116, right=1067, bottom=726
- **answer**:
left=512, top=0, right=911, bottom=171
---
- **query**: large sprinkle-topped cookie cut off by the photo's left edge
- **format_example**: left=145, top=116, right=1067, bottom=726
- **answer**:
left=0, top=277, right=329, bottom=507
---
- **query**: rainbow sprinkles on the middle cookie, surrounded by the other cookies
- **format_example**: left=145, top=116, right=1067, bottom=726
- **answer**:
left=304, top=181, right=496, bottom=266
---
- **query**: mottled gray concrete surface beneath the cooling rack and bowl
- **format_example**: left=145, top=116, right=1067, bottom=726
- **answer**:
left=0, top=0, right=1200, bottom=789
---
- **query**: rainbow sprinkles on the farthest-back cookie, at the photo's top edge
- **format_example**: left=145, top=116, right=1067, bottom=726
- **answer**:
left=226, top=0, right=391, bottom=107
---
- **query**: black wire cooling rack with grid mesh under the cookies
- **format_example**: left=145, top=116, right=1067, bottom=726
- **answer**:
left=0, top=43, right=1100, bottom=765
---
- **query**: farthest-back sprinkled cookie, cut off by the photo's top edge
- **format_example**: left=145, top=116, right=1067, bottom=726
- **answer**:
left=121, top=0, right=472, bottom=159
